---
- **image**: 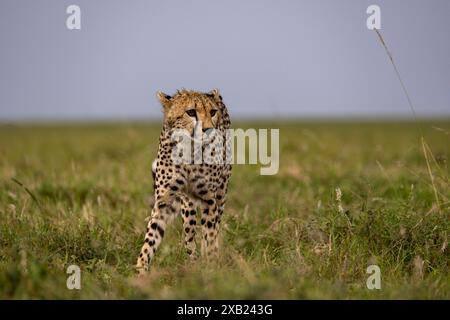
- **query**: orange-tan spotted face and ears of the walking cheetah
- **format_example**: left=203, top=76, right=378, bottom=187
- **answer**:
left=158, top=90, right=222, bottom=137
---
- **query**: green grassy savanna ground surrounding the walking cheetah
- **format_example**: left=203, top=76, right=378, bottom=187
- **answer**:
left=0, top=121, right=450, bottom=299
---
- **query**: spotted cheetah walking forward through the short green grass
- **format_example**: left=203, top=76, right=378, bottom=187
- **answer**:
left=136, top=89, right=231, bottom=274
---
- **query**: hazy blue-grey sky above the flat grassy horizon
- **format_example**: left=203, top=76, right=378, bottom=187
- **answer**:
left=0, top=0, right=450, bottom=120
